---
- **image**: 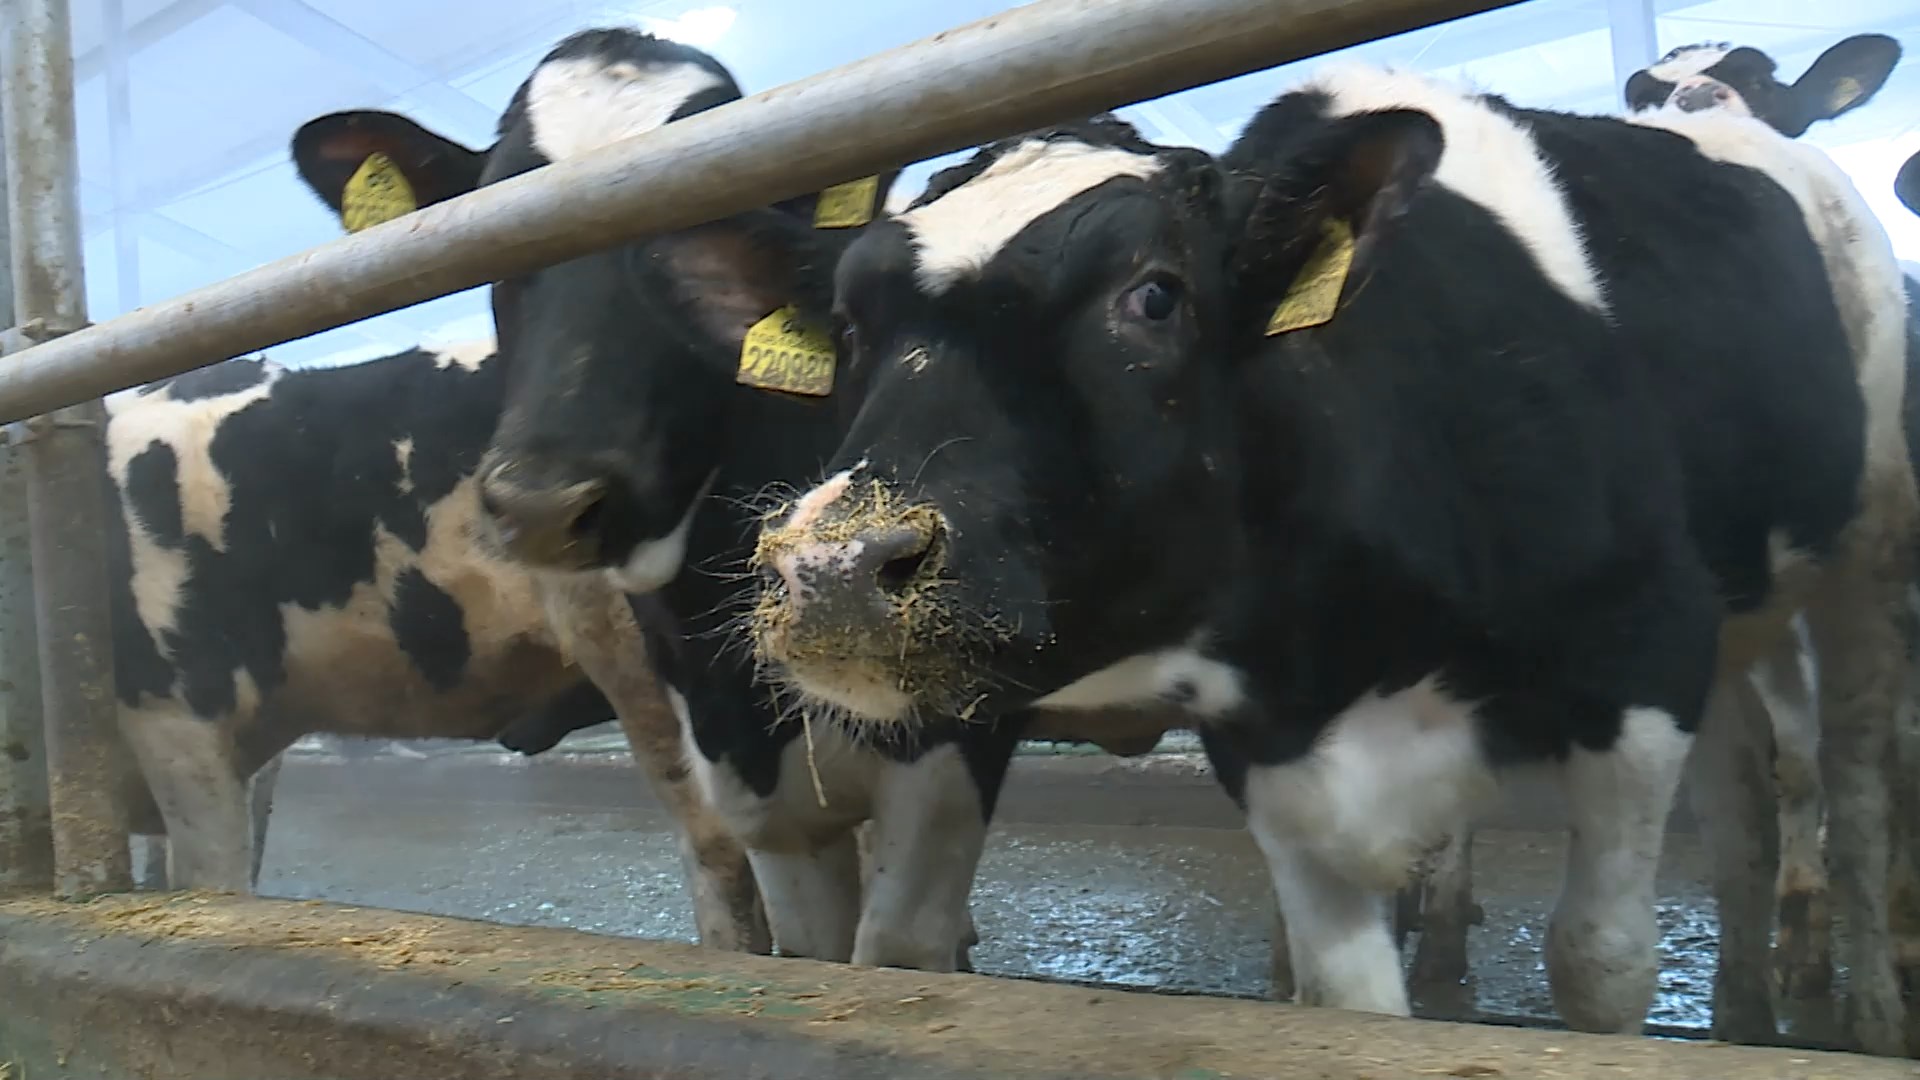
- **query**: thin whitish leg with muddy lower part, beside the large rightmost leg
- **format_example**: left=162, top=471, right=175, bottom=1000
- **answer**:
left=1753, top=621, right=1834, bottom=997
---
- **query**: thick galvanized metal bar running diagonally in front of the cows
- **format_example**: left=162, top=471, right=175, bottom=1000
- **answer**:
left=0, top=0, right=1517, bottom=423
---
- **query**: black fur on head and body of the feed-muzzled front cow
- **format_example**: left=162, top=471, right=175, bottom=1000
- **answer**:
left=802, top=85, right=1864, bottom=788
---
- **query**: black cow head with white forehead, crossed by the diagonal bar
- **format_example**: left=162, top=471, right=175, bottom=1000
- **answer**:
left=296, top=29, right=893, bottom=592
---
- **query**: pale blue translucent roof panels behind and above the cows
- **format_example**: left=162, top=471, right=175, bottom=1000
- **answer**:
left=48, top=0, right=1920, bottom=363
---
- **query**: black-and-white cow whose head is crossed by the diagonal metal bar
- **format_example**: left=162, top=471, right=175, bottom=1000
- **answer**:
left=289, top=29, right=1014, bottom=969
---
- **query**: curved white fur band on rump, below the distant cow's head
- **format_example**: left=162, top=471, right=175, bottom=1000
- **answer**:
left=1626, top=108, right=1907, bottom=475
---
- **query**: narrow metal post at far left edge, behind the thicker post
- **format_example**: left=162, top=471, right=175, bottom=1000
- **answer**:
left=0, top=105, right=54, bottom=890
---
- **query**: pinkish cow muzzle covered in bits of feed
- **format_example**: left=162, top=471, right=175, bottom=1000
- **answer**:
left=753, top=473, right=958, bottom=723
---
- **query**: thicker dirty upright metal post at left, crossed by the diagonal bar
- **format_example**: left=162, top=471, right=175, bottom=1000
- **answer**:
left=0, top=0, right=132, bottom=897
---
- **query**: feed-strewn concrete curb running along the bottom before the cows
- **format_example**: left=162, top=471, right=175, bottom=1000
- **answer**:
left=0, top=894, right=1920, bottom=1080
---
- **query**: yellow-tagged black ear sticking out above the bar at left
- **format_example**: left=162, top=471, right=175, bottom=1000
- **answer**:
left=294, top=111, right=486, bottom=233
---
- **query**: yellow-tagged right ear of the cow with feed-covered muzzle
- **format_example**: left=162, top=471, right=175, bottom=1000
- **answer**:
left=1227, top=110, right=1446, bottom=334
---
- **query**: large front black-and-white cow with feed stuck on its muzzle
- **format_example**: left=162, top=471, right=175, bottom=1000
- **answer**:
left=755, top=67, right=1920, bottom=1053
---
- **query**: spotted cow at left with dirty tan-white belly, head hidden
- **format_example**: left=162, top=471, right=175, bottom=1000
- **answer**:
left=106, top=336, right=770, bottom=951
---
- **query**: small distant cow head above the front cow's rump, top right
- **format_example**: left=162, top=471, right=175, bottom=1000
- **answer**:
left=1626, top=35, right=1901, bottom=138
